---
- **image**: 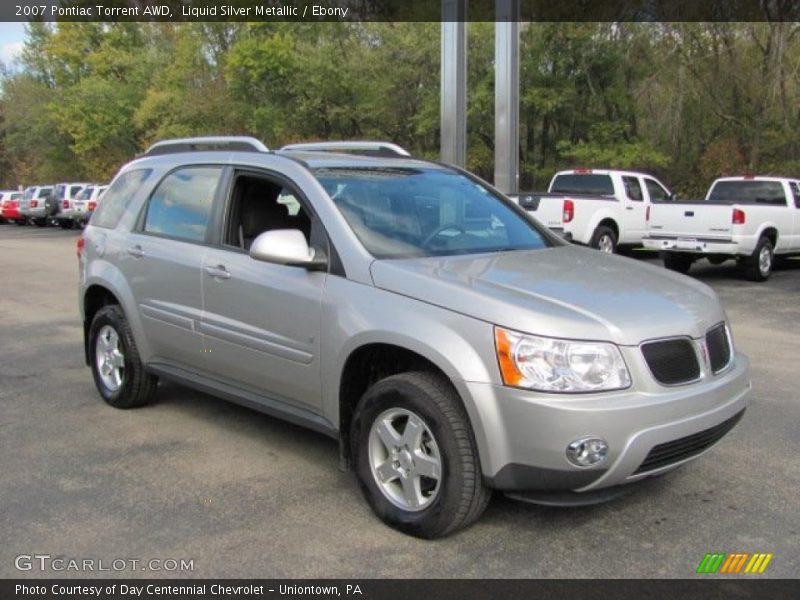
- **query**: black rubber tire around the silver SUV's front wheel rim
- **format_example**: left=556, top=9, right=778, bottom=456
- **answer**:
left=351, top=371, right=491, bottom=539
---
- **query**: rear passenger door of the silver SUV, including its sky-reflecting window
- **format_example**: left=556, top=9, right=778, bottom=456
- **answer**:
left=122, top=165, right=223, bottom=371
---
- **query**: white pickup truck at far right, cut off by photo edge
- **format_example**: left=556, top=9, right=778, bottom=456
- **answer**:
left=644, top=176, right=800, bottom=281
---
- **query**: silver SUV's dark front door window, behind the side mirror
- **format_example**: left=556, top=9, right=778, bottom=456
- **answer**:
left=223, top=173, right=312, bottom=250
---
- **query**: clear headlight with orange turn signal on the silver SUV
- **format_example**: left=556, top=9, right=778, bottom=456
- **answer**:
left=494, top=327, right=631, bottom=392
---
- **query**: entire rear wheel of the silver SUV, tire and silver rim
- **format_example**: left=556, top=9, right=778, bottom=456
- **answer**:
left=89, top=305, right=158, bottom=408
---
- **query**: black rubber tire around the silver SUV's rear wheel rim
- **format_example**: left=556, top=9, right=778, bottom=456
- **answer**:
left=89, top=304, right=158, bottom=408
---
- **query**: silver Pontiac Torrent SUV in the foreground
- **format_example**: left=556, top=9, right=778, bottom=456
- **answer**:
left=78, top=138, right=750, bottom=538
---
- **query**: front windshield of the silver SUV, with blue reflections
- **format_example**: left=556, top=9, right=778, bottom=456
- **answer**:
left=314, top=167, right=550, bottom=258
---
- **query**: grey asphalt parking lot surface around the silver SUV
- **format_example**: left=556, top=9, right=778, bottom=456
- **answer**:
left=0, top=225, right=800, bottom=578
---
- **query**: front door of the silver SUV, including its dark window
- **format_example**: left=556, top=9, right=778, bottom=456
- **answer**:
left=201, top=170, right=327, bottom=412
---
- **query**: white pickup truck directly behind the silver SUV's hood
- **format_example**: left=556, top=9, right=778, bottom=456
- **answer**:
left=510, top=169, right=673, bottom=253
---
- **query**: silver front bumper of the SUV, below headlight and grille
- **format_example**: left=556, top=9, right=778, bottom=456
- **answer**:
left=465, top=354, right=751, bottom=492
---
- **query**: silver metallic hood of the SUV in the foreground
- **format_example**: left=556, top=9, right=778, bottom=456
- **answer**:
left=371, top=246, right=725, bottom=345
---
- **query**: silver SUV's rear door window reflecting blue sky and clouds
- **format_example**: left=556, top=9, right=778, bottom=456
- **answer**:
left=144, top=167, right=222, bottom=242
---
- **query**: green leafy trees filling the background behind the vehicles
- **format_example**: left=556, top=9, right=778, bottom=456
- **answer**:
left=0, top=23, right=800, bottom=195
